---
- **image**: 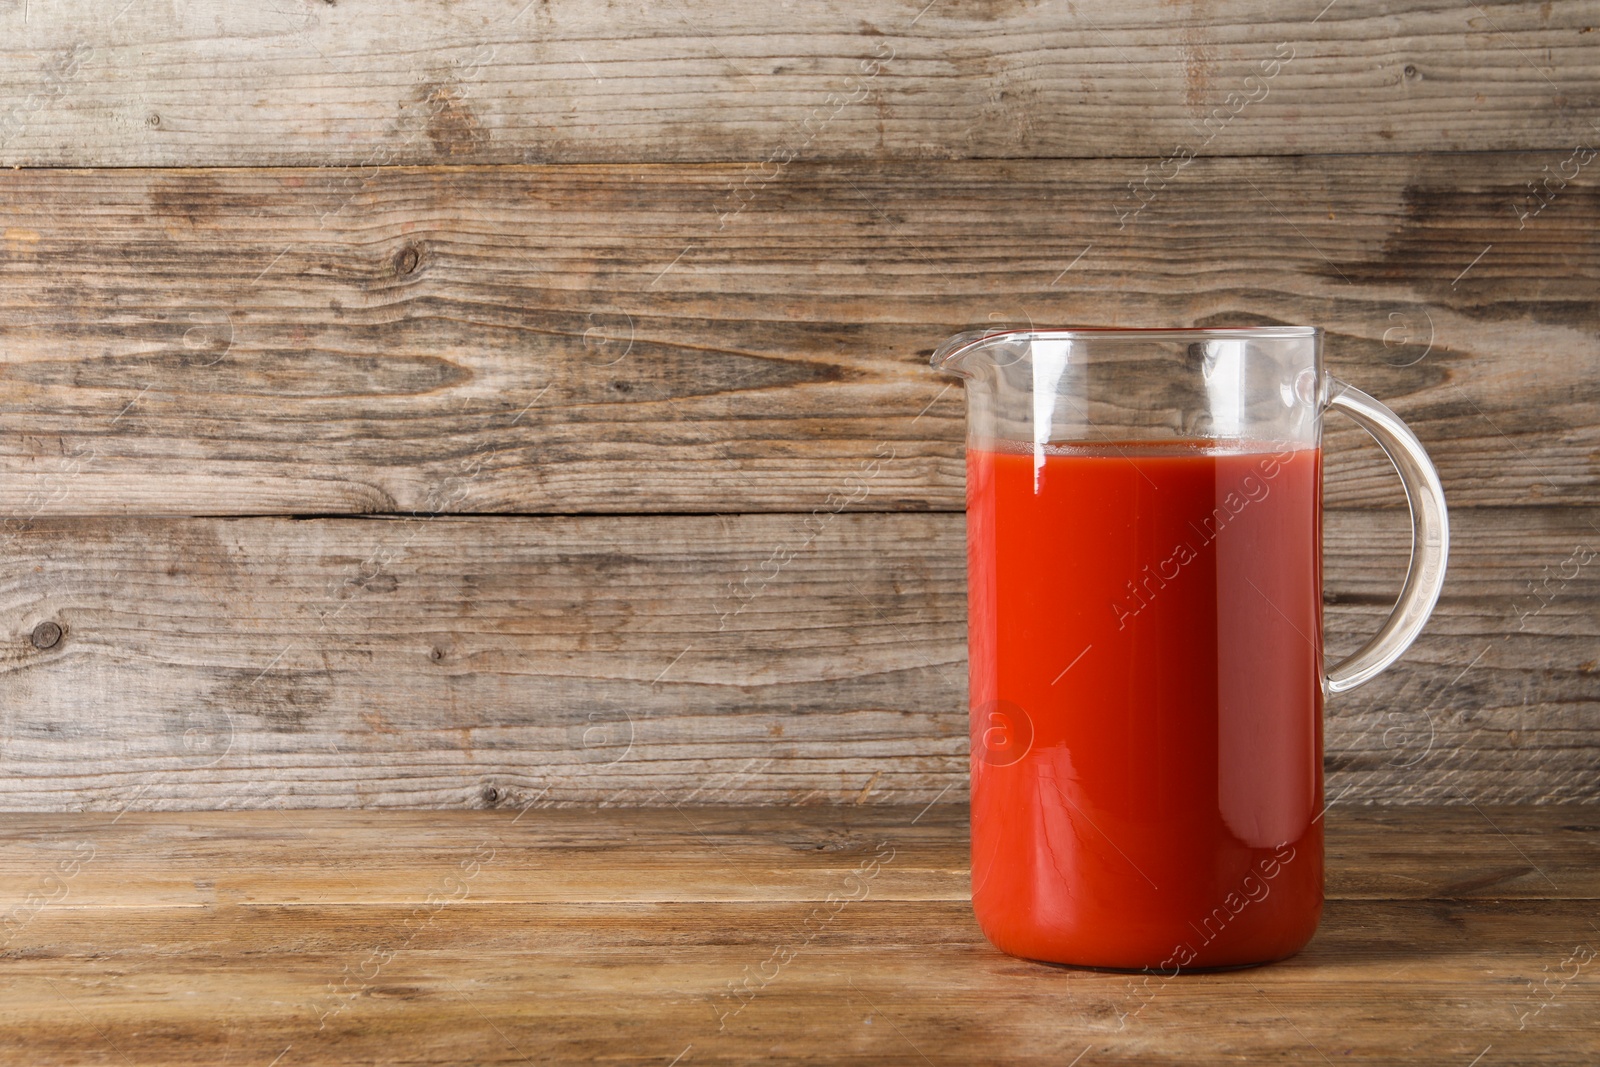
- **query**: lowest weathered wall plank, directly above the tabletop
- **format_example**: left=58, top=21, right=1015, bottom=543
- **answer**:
left=0, top=507, right=1600, bottom=811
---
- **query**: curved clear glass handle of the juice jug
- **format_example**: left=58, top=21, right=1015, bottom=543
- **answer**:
left=1323, top=374, right=1450, bottom=694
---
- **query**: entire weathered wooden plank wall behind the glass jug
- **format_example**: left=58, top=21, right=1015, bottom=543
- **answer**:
left=0, top=0, right=1600, bottom=811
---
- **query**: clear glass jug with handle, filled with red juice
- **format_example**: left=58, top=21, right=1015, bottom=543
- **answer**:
left=933, top=326, right=1450, bottom=974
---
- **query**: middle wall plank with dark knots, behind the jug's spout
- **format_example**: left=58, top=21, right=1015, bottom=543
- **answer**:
left=0, top=151, right=1600, bottom=518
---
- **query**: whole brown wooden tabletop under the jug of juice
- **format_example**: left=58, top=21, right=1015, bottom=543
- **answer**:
left=0, top=806, right=1600, bottom=1067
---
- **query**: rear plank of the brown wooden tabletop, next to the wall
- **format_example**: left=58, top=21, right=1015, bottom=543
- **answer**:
left=0, top=803, right=1600, bottom=908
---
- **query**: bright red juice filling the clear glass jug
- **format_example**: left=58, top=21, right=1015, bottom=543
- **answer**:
left=966, top=442, right=1322, bottom=974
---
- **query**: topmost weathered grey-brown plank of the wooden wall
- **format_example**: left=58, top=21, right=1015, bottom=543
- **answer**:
left=0, top=0, right=1600, bottom=166
